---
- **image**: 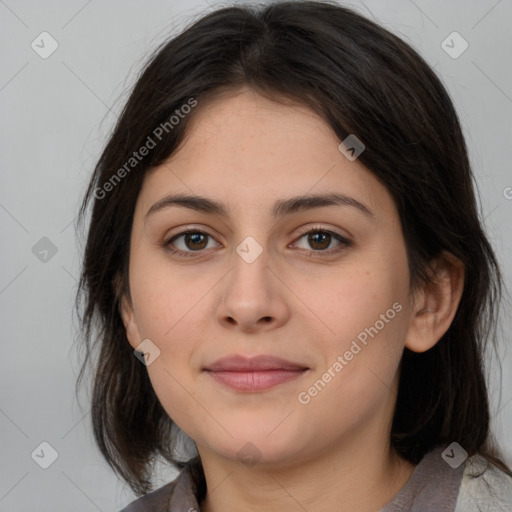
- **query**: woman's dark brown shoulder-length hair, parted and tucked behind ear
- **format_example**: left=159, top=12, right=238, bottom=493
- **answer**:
left=75, top=1, right=512, bottom=495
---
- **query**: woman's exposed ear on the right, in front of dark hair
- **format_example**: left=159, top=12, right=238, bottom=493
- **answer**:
left=405, top=251, right=464, bottom=352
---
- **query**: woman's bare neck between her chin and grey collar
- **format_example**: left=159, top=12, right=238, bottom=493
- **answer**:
left=196, top=439, right=415, bottom=512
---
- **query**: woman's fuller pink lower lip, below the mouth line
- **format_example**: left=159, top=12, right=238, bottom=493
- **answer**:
left=208, top=370, right=307, bottom=392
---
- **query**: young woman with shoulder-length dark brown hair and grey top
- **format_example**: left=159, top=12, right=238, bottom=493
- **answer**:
left=75, top=2, right=512, bottom=512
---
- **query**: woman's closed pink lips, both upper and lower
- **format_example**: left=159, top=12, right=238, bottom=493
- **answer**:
left=204, top=355, right=309, bottom=392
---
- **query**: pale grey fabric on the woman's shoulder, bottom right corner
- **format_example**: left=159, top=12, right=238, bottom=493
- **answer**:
left=455, top=455, right=512, bottom=512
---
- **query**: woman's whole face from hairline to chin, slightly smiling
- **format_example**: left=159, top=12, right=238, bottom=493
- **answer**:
left=123, top=90, right=420, bottom=463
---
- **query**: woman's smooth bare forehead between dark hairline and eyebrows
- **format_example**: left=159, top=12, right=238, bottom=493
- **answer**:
left=135, top=90, right=391, bottom=221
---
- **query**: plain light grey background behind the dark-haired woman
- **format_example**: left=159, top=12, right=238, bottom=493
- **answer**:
left=0, top=0, right=512, bottom=512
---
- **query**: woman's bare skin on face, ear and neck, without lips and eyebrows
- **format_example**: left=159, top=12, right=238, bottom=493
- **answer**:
left=121, top=89, right=463, bottom=512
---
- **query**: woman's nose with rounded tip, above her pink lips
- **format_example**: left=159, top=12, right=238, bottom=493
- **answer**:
left=217, top=246, right=290, bottom=332
